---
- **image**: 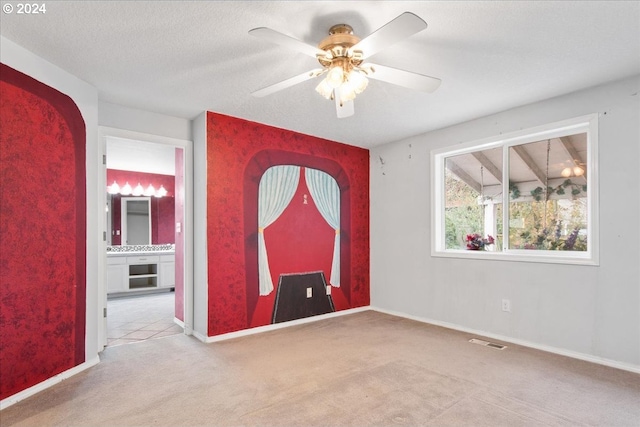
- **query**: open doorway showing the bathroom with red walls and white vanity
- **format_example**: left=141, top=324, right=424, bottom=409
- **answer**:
left=100, top=128, right=193, bottom=348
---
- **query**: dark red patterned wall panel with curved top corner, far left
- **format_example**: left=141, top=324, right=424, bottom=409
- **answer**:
left=0, top=64, right=86, bottom=399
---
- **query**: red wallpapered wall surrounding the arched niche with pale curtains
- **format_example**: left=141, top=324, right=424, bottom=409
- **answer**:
left=202, top=113, right=369, bottom=336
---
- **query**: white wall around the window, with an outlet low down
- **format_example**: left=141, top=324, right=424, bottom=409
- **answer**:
left=371, top=77, right=640, bottom=370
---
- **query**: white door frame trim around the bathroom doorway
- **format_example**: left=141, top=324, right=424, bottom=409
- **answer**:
left=97, top=126, right=194, bottom=352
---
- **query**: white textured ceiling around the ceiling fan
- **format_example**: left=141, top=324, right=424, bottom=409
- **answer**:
left=0, top=1, right=640, bottom=147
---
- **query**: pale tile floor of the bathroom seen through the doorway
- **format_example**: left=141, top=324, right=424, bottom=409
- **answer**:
left=107, top=292, right=183, bottom=347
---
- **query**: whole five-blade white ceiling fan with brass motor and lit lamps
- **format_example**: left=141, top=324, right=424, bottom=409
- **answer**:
left=249, top=12, right=440, bottom=118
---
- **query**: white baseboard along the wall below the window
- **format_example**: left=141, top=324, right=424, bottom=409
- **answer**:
left=370, top=307, right=640, bottom=374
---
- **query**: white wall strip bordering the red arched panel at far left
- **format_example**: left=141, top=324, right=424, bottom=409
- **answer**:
left=0, top=37, right=104, bottom=362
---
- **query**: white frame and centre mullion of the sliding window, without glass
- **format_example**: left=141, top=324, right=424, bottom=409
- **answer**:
left=431, top=114, right=599, bottom=265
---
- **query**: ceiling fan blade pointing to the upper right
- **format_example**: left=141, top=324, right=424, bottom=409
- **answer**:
left=352, top=12, right=427, bottom=59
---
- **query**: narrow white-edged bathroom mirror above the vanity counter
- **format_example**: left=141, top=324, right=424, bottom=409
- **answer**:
left=121, top=197, right=151, bottom=245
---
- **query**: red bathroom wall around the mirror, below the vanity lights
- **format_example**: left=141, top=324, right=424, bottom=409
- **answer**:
left=107, top=169, right=175, bottom=245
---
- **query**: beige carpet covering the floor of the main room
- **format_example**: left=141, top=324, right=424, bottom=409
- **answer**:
left=0, top=311, right=640, bottom=427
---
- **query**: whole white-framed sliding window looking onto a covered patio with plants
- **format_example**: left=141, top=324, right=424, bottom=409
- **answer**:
left=431, top=115, right=598, bottom=264
